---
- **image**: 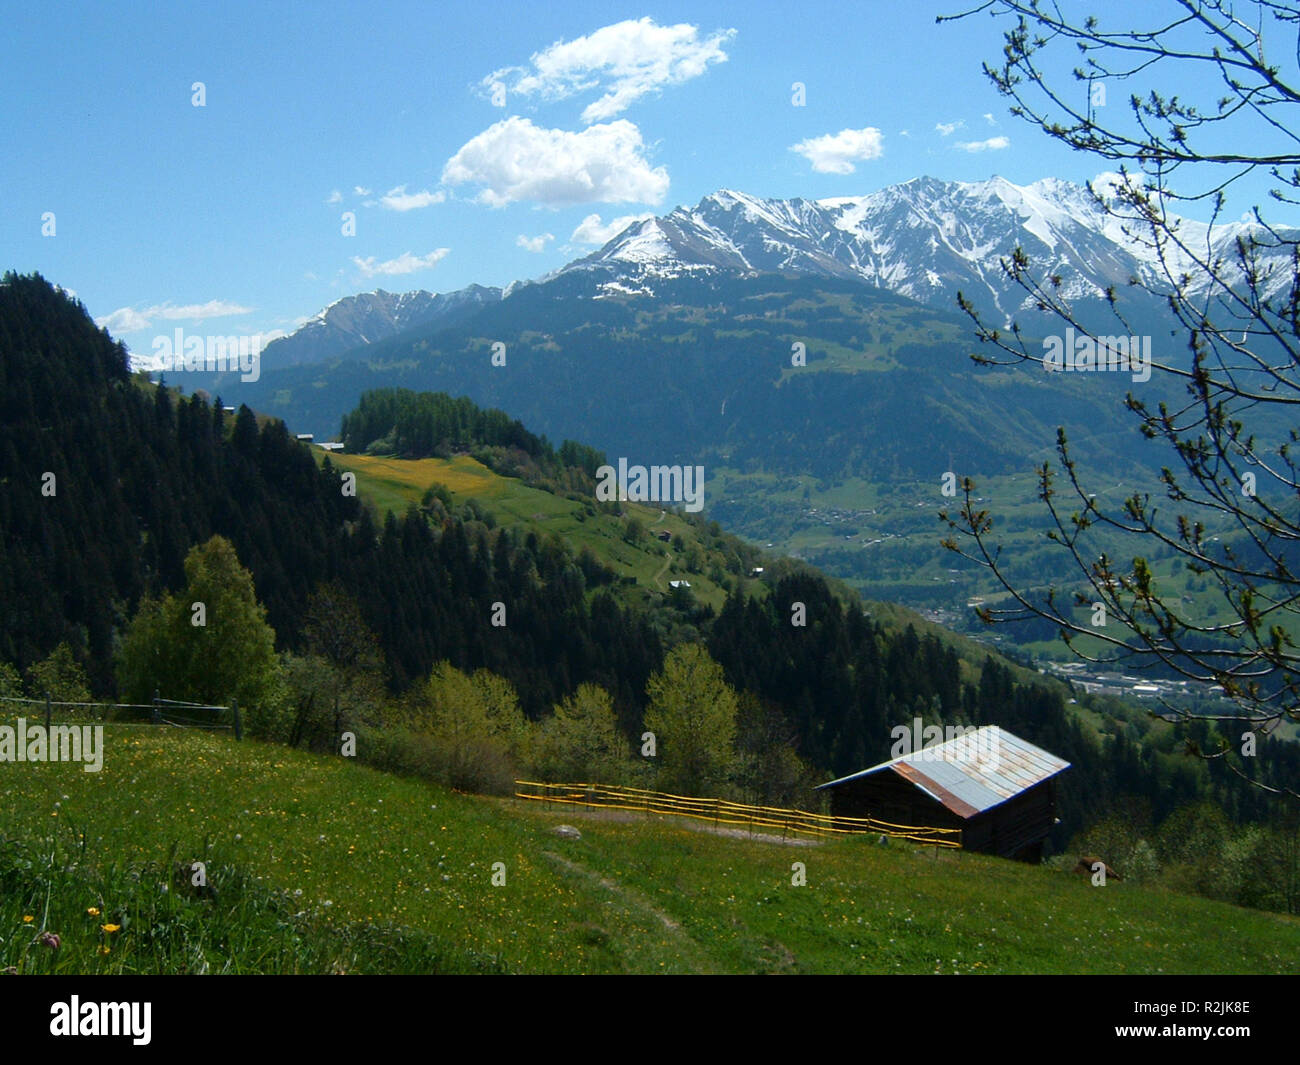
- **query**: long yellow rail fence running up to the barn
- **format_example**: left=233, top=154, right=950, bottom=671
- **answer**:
left=515, top=780, right=962, bottom=848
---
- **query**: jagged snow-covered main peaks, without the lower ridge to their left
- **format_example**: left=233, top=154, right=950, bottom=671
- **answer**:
left=559, top=177, right=1294, bottom=320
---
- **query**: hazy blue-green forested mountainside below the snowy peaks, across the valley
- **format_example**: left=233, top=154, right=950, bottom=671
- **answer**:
left=192, top=274, right=1180, bottom=629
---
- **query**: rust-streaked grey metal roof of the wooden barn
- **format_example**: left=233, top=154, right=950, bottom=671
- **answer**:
left=818, top=724, right=1070, bottom=818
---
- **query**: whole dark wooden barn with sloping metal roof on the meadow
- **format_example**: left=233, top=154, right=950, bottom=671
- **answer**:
left=818, top=724, right=1070, bottom=862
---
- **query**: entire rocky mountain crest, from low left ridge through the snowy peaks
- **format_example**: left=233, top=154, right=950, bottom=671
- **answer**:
left=265, top=174, right=1294, bottom=365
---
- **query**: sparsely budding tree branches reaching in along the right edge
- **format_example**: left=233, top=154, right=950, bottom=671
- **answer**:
left=940, top=0, right=1300, bottom=796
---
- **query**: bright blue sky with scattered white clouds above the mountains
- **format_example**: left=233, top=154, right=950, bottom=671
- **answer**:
left=0, top=0, right=1289, bottom=352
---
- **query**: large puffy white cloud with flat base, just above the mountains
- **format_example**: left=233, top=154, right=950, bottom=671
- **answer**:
left=442, top=116, right=668, bottom=207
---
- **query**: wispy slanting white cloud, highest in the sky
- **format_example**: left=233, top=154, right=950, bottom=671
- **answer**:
left=481, top=17, right=736, bottom=122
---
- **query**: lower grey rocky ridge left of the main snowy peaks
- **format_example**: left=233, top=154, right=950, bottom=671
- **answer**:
left=263, top=285, right=502, bottom=367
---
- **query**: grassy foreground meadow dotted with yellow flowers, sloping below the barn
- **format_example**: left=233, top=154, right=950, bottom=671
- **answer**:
left=0, top=726, right=1300, bottom=973
